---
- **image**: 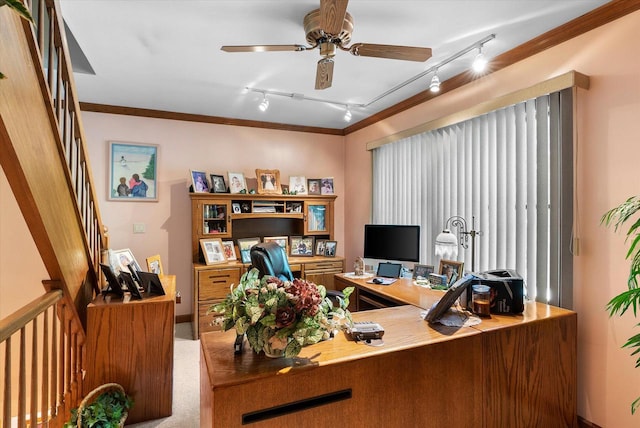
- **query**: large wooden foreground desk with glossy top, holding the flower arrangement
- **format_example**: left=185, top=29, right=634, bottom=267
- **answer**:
left=200, top=275, right=577, bottom=428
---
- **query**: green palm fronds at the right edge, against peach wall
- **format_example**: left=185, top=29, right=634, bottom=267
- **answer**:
left=601, top=196, right=640, bottom=414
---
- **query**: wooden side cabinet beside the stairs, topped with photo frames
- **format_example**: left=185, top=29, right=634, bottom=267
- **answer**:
left=84, top=275, right=176, bottom=423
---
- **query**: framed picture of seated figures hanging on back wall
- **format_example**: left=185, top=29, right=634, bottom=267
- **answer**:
left=107, top=141, right=158, bottom=202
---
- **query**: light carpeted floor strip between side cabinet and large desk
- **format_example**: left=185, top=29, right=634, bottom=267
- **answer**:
left=127, top=323, right=200, bottom=428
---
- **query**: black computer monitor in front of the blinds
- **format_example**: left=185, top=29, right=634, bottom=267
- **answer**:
left=364, top=224, right=420, bottom=262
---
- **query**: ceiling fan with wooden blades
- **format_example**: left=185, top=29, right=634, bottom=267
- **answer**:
left=221, top=0, right=431, bottom=89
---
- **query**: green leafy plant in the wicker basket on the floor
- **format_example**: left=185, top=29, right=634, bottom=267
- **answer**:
left=64, top=390, right=133, bottom=428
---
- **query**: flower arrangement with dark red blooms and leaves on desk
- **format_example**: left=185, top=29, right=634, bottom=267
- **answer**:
left=214, top=268, right=353, bottom=358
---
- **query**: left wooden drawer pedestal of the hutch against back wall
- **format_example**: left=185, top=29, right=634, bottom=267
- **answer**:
left=193, top=263, right=243, bottom=339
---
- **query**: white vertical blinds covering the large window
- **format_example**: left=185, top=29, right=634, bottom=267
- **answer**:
left=372, top=90, right=573, bottom=306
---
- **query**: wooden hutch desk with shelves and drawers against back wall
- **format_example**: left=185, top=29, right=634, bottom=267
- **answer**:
left=190, top=193, right=345, bottom=339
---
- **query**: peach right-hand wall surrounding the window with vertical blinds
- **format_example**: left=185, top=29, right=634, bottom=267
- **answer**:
left=345, top=12, right=640, bottom=428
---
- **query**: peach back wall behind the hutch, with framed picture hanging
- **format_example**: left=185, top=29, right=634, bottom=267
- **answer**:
left=82, top=112, right=345, bottom=315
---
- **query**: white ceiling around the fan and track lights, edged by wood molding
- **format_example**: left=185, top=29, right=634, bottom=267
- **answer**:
left=60, top=0, right=608, bottom=129
